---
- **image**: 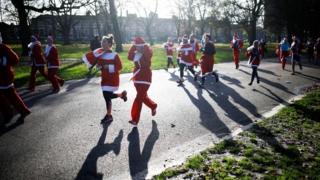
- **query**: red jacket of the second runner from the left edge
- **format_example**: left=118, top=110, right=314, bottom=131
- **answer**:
left=29, top=41, right=46, bottom=66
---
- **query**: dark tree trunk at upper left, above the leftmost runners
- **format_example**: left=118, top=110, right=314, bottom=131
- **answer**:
left=11, top=0, right=31, bottom=56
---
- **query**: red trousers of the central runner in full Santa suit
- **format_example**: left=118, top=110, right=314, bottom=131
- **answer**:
left=131, top=83, right=157, bottom=123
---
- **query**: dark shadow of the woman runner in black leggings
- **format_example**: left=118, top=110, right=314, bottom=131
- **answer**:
left=75, top=123, right=123, bottom=180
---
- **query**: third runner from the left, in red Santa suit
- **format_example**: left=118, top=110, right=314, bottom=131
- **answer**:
left=44, top=36, right=64, bottom=93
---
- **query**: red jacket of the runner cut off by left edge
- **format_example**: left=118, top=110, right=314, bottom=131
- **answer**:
left=0, top=44, right=19, bottom=89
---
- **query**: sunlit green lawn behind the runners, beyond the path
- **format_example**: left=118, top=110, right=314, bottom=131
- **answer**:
left=11, top=44, right=274, bottom=87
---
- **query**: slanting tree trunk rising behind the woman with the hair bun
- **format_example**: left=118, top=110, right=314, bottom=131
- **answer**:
left=109, top=0, right=123, bottom=52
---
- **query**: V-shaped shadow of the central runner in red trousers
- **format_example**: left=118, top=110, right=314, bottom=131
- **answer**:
left=128, top=120, right=159, bottom=179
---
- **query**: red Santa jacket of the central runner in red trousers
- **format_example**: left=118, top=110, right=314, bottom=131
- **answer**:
left=128, top=45, right=152, bottom=85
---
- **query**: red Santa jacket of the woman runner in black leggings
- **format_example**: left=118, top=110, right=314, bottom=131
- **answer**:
left=82, top=48, right=122, bottom=92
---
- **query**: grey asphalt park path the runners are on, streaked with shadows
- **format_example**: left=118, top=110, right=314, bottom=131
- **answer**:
left=0, top=58, right=320, bottom=180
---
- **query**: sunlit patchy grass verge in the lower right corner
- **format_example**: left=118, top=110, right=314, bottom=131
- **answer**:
left=153, top=86, right=320, bottom=180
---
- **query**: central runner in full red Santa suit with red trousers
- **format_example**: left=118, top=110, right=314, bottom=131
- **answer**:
left=128, top=37, right=157, bottom=126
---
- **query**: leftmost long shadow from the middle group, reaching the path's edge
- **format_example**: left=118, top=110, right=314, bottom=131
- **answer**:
left=181, top=86, right=231, bottom=137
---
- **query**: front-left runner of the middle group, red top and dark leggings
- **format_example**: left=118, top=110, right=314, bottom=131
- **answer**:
left=177, top=35, right=198, bottom=84
